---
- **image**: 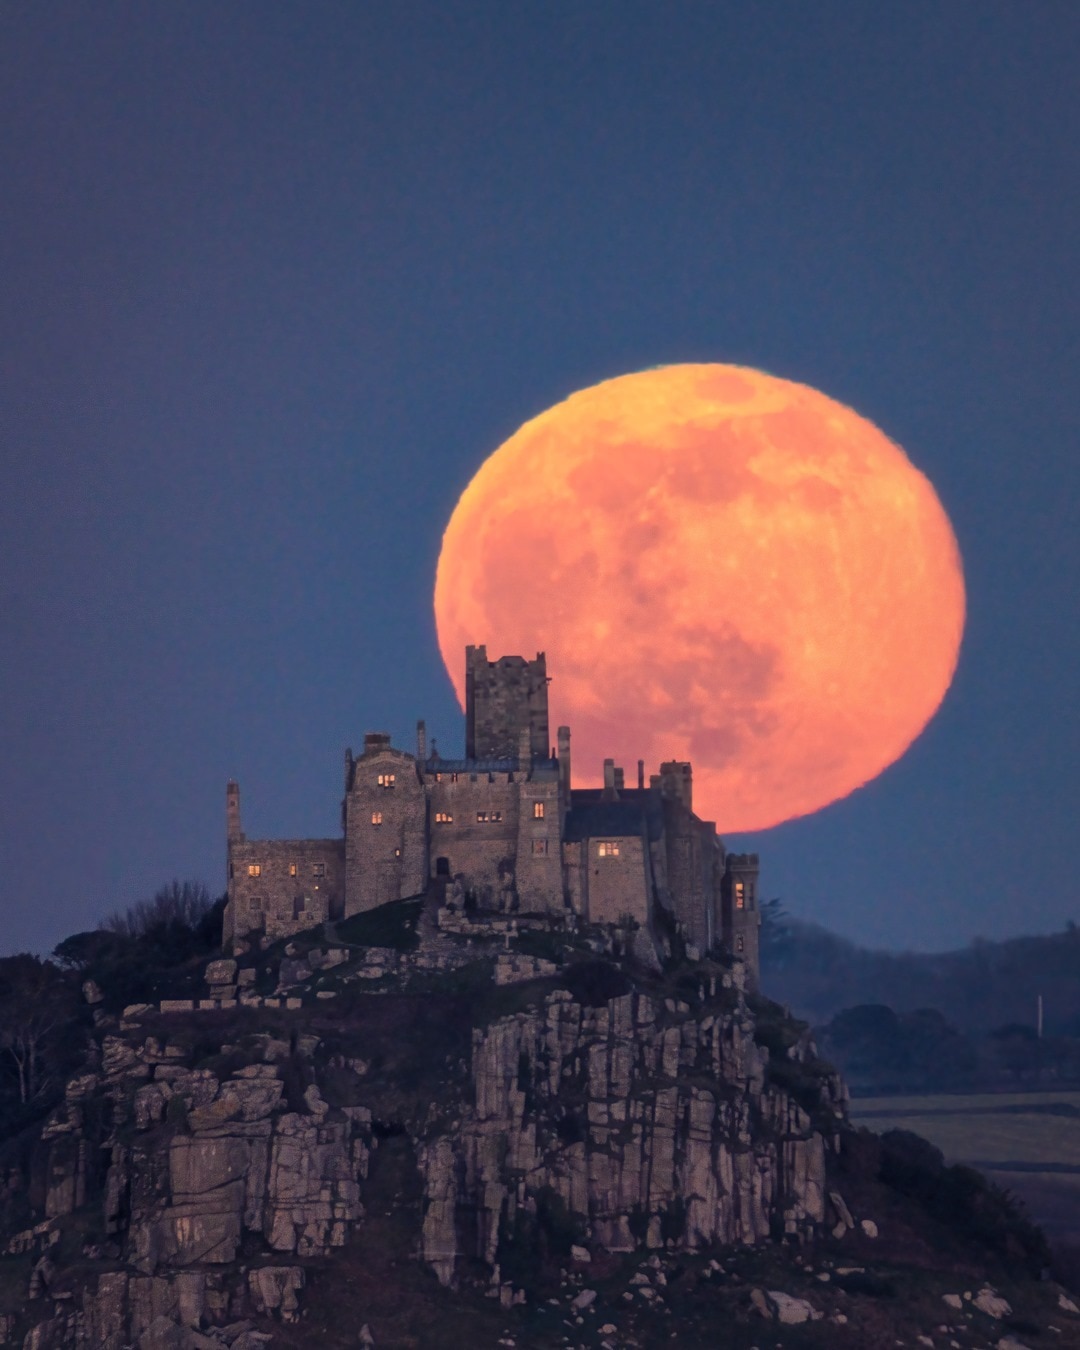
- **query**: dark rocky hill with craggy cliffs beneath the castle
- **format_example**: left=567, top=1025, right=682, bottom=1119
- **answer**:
left=0, top=903, right=1080, bottom=1350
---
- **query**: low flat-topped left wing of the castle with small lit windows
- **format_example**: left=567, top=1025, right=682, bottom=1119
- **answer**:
left=225, top=840, right=346, bottom=941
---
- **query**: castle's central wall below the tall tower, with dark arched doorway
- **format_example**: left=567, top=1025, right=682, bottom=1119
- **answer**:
left=425, top=771, right=521, bottom=909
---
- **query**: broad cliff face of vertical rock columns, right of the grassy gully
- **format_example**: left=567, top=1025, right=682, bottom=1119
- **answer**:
left=420, top=976, right=845, bottom=1284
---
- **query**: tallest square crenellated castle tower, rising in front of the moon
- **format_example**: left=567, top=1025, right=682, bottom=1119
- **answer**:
left=464, top=647, right=551, bottom=760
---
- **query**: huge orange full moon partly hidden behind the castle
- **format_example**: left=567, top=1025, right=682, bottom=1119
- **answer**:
left=435, top=365, right=964, bottom=832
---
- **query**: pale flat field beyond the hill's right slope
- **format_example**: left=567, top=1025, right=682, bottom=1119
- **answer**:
left=852, top=1091, right=1080, bottom=1241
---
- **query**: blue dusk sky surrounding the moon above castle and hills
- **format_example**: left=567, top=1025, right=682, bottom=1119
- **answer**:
left=0, top=0, right=1080, bottom=952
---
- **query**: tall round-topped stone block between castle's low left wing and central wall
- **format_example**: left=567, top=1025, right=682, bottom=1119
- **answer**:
left=344, top=744, right=428, bottom=915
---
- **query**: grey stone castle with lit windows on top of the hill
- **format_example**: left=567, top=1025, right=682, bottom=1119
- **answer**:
left=224, top=647, right=760, bottom=984
